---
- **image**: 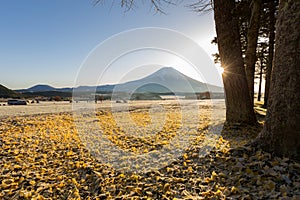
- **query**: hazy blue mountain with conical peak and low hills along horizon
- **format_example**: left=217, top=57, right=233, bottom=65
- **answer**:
left=17, top=67, right=224, bottom=96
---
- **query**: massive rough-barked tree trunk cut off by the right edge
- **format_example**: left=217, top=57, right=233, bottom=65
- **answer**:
left=257, top=0, right=300, bottom=160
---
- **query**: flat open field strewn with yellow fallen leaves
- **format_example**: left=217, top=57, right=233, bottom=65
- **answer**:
left=0, top=101, right=300, bottom=199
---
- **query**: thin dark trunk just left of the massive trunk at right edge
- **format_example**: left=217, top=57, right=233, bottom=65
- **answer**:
left=264, top=1, right=276, bottom=108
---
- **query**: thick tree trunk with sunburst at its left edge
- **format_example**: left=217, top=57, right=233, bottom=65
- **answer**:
left=214, top=0, right=256, bottom=125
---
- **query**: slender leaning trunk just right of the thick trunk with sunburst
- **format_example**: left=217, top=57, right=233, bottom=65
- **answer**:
left=245, top=0, right=262, bottom=104
